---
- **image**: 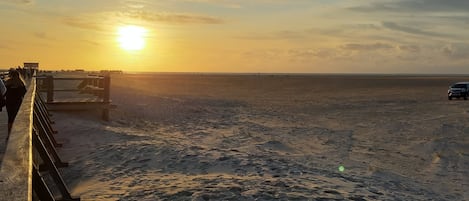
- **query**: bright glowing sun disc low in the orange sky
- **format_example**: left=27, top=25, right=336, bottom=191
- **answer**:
left=117, top=25, right=147, bottom=50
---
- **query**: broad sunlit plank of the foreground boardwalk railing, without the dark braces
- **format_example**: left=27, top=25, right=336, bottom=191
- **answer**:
left=0, top=79, right=36, bottom=201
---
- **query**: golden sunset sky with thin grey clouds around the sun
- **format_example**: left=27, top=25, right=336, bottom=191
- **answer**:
left=0, top=0, right=469, bottom=74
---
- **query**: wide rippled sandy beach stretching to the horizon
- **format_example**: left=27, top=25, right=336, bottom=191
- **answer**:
left=52, top=74, right=469, bottom=201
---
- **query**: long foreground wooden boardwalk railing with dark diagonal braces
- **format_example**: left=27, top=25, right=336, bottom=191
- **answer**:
left=0, top=76, right=80, bottom=201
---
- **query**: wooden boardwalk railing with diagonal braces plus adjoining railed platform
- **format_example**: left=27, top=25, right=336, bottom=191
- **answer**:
left=0, top=72, right=110, bottom=201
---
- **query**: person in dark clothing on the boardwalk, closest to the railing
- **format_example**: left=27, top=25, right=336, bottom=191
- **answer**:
left=5, top=69, right=26, bottom=137
